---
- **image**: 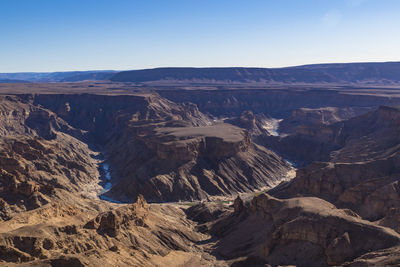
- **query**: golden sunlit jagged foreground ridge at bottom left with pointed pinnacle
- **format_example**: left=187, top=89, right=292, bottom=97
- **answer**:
left=0, top=197, right=216, bottom=266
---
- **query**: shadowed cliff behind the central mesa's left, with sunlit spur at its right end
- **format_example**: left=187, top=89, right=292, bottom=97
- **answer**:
left=29, top=94, right=210, bottom=144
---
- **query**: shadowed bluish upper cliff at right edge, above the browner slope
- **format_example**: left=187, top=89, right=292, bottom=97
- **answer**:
left=261, top=106, right=400, bottom=166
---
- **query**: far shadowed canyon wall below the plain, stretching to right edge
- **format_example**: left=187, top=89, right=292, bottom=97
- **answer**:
left=157, top=89, right=400, bottom=118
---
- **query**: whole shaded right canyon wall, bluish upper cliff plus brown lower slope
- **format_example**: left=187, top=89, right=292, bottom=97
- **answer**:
left=271, top=107, right=400, bottom=225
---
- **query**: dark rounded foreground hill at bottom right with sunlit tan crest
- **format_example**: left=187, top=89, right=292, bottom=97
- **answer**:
left=195, top=194, right=400, bottom=266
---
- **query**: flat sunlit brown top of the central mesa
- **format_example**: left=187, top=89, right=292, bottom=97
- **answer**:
left=156, top=123, right=244, bottom=142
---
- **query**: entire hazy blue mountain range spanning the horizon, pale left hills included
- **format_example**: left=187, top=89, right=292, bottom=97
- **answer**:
left=0, top=62, right=400, bottom=85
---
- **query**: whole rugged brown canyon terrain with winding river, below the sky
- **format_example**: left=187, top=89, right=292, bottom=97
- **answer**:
left=0, top=64, right=400, bottom=267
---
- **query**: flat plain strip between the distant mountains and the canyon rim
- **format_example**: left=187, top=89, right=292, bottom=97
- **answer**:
left=0, top=81, right=400, bottom=97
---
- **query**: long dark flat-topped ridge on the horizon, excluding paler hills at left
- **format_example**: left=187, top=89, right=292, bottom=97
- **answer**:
left=111, top=62, right=400, bottom=84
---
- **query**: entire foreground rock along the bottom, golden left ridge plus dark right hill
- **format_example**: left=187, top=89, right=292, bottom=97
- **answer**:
left=4, top=194, right=400, bottom=266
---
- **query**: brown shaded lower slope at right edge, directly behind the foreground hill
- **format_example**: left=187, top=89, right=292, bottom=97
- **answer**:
left=270, top=156, right=400, bottom=221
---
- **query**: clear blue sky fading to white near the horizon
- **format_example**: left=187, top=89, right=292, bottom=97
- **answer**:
left=0, top=0, right=400, bottom=72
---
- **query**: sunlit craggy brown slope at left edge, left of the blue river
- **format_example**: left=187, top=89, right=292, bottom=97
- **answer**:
left=0, top=135, right=98, bottom=219
